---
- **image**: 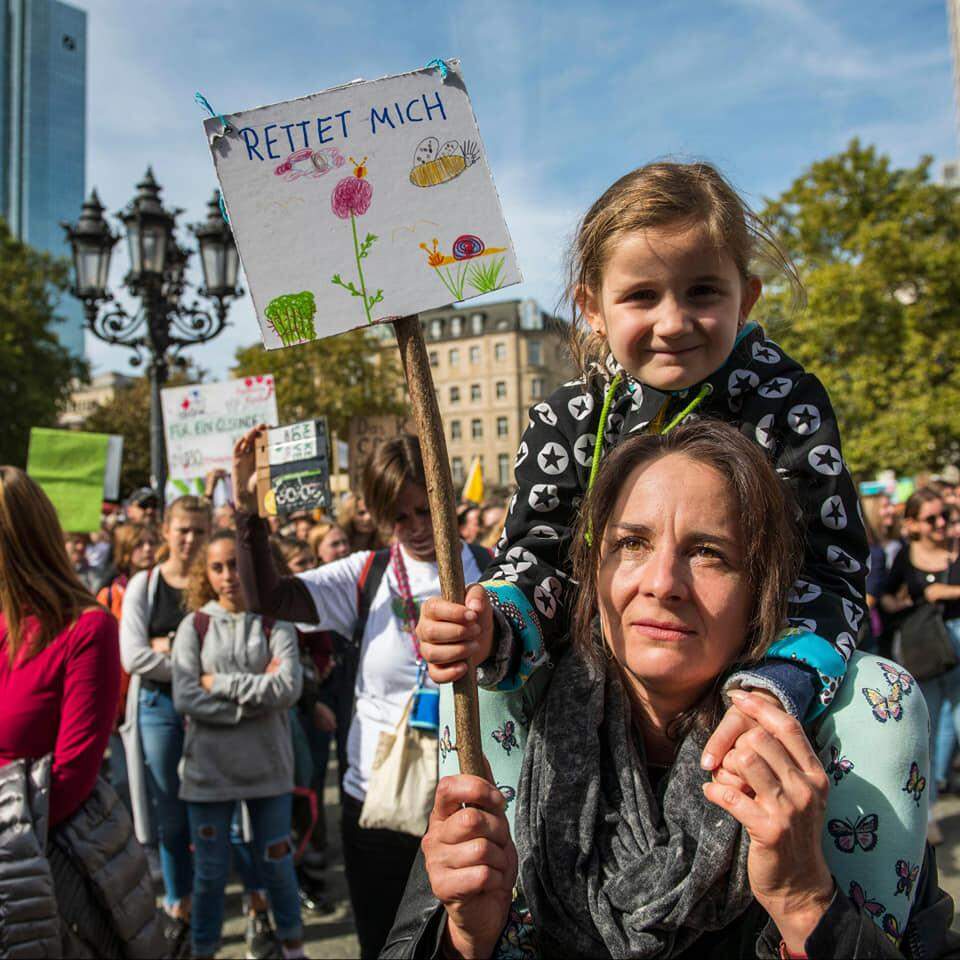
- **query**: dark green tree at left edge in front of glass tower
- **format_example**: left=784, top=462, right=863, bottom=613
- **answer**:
left=0, top=219, right=87, bottom=467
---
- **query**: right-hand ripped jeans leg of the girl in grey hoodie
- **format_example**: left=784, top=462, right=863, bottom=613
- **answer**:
left=247, top=793, right=303, bottom=946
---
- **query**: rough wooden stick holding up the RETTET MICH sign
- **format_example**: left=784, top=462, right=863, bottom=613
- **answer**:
left=394, top=315, right=487, bottom=778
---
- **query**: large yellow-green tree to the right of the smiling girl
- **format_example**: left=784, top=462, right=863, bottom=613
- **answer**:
left=758, top=140, right=960, bottom=477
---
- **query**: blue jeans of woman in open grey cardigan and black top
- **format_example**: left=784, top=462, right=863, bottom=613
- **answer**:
left=138, top=689, right=193, bottom=906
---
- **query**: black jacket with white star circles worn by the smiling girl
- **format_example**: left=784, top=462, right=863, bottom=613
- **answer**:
left=484, top=326, right=868, bottom=703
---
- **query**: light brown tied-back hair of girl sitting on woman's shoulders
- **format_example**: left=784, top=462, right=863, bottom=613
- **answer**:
left=564, top=161, right=803, bottom=375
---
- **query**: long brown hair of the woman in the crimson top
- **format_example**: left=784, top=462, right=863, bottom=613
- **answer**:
left=0, top=467, right=97, bottom=665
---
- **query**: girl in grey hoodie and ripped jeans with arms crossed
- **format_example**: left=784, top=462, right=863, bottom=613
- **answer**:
left=173, top=530, right=303, bottom=957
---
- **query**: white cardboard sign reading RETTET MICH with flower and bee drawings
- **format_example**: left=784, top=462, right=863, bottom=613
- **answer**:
left=205, top=60, right=521, bottom=349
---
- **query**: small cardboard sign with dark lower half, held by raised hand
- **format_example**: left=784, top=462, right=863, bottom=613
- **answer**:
left=256, top=420, right=331, bottom=517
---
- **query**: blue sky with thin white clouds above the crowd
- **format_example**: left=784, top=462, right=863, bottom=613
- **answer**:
left=74, top=0, right=960, bottom=377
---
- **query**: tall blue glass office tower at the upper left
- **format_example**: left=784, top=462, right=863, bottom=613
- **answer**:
left=0, top=0, right=87, bottom=356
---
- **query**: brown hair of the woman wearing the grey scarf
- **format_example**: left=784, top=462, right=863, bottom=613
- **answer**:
left=571, top=420, right=802, bottom=730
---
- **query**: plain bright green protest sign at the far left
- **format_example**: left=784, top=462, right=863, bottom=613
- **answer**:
left=27, top=427, right=123, bottom=533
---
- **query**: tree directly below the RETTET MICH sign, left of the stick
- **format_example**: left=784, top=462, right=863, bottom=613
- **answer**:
left=232, top=329, right=406, bottom=439
